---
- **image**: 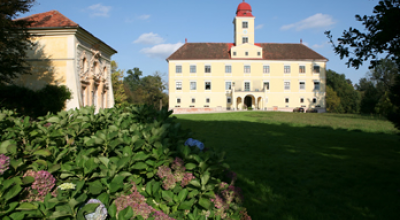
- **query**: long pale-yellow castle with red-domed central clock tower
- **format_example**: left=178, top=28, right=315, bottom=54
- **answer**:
left=167, top=1, right=328, bottom=113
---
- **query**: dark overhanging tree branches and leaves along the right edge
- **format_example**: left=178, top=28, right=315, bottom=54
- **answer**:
left=325, top=0, right=400, bottom=128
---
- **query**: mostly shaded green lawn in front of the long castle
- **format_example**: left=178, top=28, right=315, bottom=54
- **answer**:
left=176, top=112, right=400, bottom=220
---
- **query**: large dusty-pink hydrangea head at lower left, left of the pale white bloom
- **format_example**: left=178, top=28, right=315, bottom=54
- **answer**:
left=22, top=170, right=56, bottom=202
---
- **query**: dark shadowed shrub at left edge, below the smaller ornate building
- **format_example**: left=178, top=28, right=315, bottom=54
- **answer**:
left=0, top=85, right=71, bottom=118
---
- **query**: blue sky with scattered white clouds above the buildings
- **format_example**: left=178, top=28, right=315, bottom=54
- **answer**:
left=19, top=0, right=378, bottom=83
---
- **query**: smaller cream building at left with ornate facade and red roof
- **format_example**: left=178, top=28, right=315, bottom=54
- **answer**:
left=14, top=10, right=117, bottom=112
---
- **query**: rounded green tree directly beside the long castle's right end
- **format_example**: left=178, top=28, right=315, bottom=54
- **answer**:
left=326, top=70, right=361, bottom=113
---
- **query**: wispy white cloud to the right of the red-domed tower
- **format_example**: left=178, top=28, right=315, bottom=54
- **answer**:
left=281, top=13, right=336, bottom=31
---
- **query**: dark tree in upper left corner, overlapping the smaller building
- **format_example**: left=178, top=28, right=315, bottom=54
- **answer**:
left=0, top=0, right=35, bottom=84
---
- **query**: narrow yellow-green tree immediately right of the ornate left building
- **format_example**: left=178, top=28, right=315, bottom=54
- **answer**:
left=111, top=60, right=128, bottom=107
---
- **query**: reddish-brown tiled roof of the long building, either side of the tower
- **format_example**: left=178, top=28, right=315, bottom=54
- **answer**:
left=167, top=43, right=328, bottom=60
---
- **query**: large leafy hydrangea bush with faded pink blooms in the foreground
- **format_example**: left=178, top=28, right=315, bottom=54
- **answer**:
left=0, top=106, right=251, bottom=220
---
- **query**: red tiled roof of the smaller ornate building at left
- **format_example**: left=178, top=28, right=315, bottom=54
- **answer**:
left=16, top=10, right=79, bottom=28
